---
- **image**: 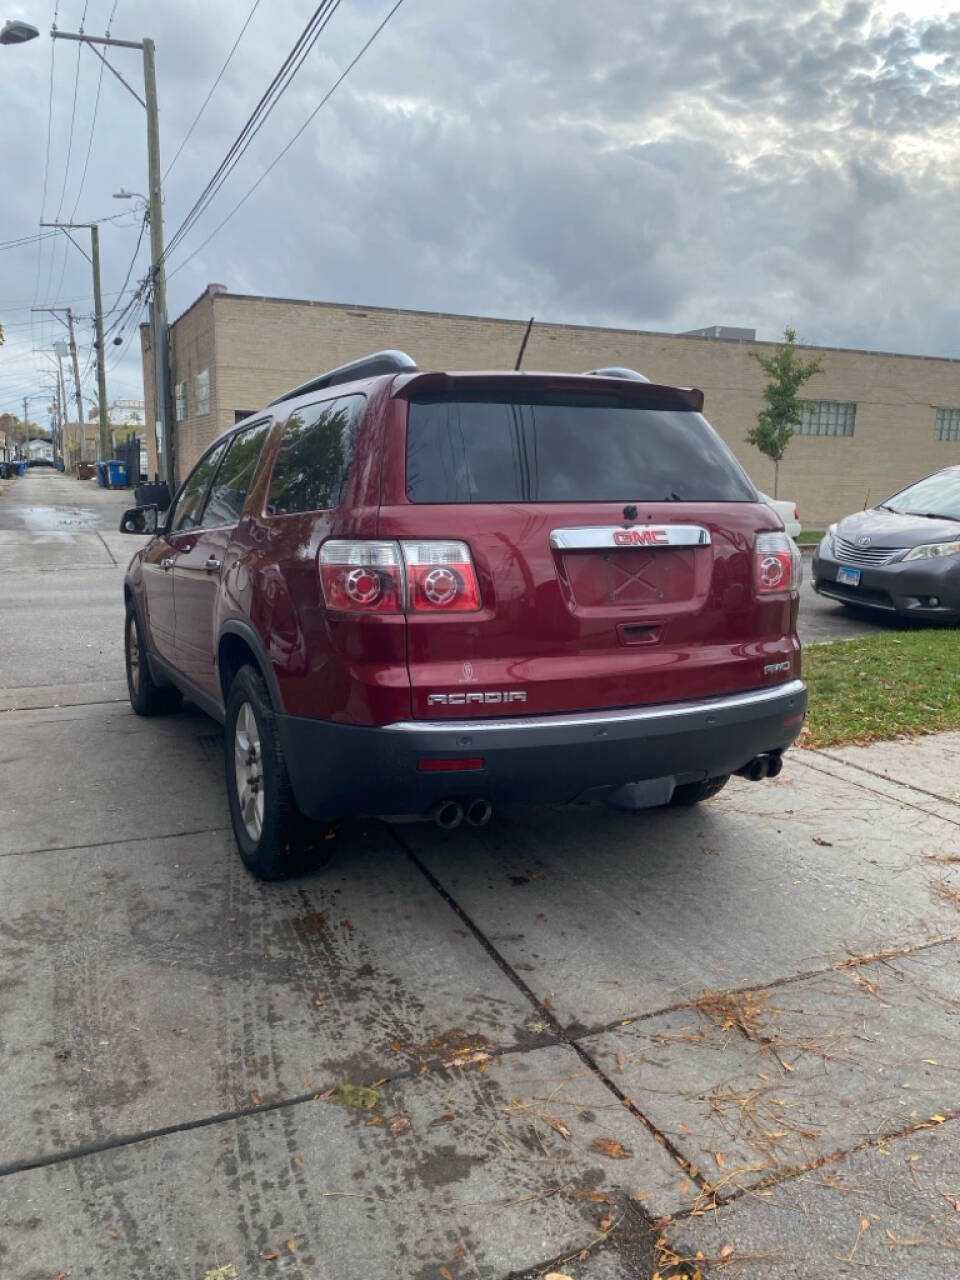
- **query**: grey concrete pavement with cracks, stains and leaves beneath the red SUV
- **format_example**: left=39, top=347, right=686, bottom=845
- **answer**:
left=0, top=472, right=960, bottom=1280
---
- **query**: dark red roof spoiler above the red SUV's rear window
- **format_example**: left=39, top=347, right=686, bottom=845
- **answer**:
left=390, top=371, right=704, bottom=413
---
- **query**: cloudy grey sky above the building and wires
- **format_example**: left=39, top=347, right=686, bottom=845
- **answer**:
left=0, top=0, right=960, bottom=416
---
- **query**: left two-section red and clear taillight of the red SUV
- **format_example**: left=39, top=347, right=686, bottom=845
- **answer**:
left=320, top=539, right=480, bottom=613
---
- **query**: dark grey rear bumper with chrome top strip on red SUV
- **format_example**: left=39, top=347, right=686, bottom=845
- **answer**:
left=278, top=680, right=806, bottom=819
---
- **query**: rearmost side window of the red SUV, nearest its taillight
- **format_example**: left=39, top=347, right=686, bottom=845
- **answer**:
left=268, top=396, right=366, bottom=516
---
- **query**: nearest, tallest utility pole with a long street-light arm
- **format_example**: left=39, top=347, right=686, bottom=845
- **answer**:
left=50, top=28, right=175, bottom=493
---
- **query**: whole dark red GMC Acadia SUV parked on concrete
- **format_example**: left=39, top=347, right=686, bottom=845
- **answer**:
left=120, top=352, right=806, bottom=878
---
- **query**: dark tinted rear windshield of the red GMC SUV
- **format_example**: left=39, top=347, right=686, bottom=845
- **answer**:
left=407, top=394, right=756, bottom=503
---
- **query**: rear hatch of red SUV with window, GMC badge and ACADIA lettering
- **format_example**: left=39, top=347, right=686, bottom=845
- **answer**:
left=378, top=374, right=799, bottom=719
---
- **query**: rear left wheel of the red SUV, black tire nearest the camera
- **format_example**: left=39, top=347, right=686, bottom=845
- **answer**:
left=224, top=666, right=329, bottom=881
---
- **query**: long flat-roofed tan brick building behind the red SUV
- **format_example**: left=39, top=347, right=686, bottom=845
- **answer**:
left=141, top=284, right=960, bottom=527
